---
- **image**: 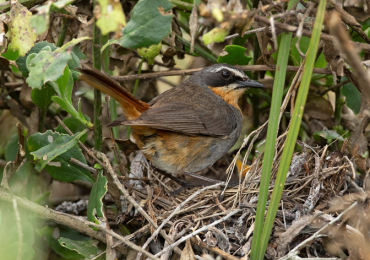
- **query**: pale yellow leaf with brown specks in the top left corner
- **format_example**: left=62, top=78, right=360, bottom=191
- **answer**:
left=9, top=1, right=37, bottom=56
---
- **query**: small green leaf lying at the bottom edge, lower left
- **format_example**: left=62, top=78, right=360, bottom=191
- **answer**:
left=58, top=237, right=98, bottom=259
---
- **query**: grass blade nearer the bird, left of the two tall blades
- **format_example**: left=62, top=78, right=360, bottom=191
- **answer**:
left=251, top=0, right=297, bottom=259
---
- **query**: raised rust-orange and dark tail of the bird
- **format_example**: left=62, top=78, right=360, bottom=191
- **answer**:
left=78, top=69, right=149, bottom=120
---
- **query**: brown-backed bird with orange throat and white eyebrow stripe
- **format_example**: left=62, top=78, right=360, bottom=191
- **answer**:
left=79, top=64, right=264, bottom=183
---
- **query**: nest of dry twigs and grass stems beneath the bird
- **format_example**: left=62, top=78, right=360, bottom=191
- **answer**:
left=102, top=128, right=370, bottom=259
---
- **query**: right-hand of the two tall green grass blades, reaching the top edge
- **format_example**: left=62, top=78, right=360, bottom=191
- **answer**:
left=252, top=0, right=326, bottom=260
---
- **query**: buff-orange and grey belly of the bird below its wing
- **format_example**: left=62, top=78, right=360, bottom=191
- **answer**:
left=134, top=130, right=240, bottom=175
